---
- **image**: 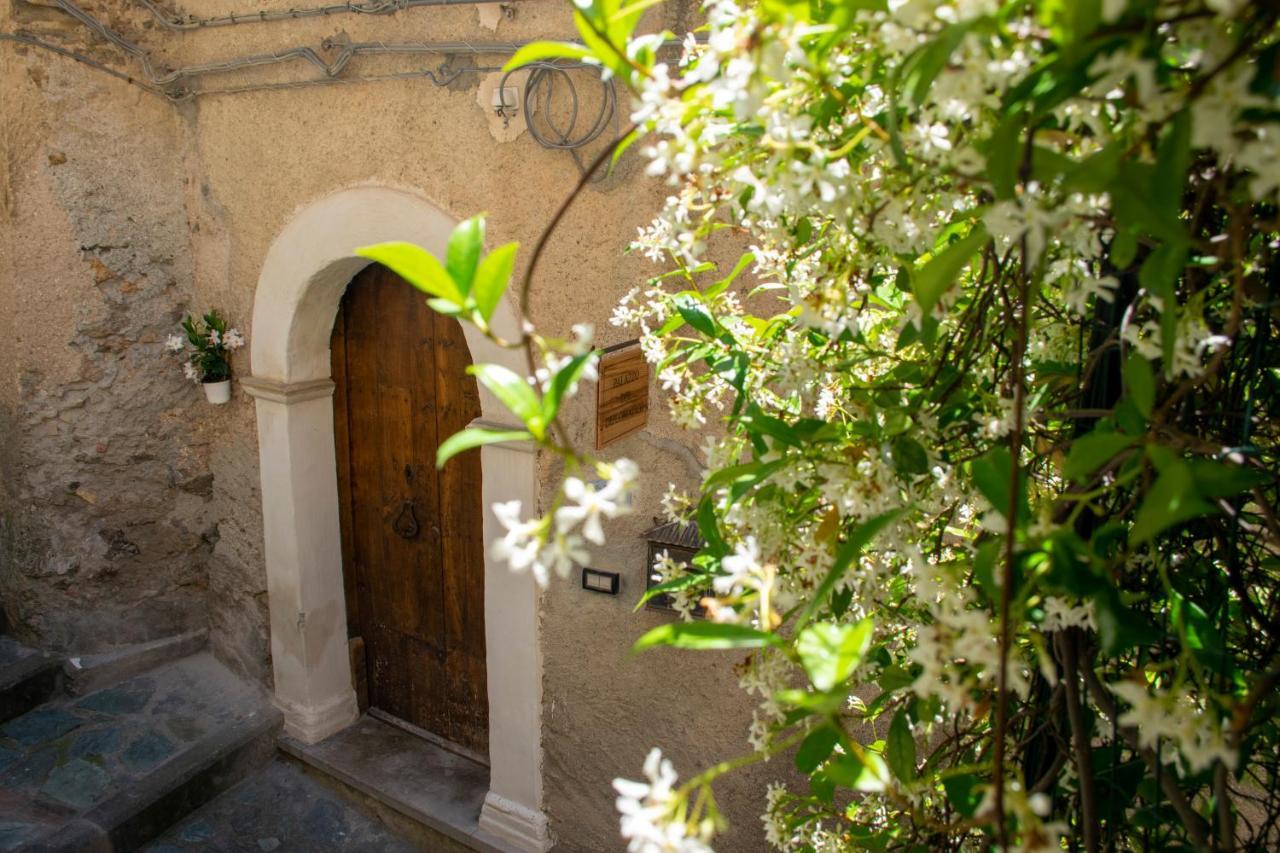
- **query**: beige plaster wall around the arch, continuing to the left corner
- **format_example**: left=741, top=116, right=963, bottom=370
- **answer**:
left=0, top=0, right=763, bottom=850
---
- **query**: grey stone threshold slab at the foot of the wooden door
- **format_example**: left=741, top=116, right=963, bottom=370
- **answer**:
left=279, top=713, right=515, bottom=853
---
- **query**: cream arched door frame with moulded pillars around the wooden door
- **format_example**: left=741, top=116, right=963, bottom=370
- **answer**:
left=241, top=186, right=549, bottom=850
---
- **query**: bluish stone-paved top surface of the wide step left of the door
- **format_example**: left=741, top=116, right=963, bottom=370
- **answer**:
left=0, top=653, right=274, bottom=850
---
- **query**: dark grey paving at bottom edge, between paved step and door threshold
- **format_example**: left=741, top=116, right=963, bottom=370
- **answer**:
left=143, top=760, right=422, bottom=853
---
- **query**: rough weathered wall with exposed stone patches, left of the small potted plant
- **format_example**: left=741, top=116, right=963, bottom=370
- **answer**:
left=0, top=1, right=218, bottom=652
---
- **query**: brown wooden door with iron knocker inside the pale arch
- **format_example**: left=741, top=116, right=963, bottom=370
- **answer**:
left=332, top=264, right=489, bottom=761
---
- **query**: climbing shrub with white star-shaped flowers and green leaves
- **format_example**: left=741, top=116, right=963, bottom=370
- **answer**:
left=371, top=0, right=1280, bottom=852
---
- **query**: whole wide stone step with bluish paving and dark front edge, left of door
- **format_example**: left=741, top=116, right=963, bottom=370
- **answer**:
left=0, top=653, right=280, bottom=853
